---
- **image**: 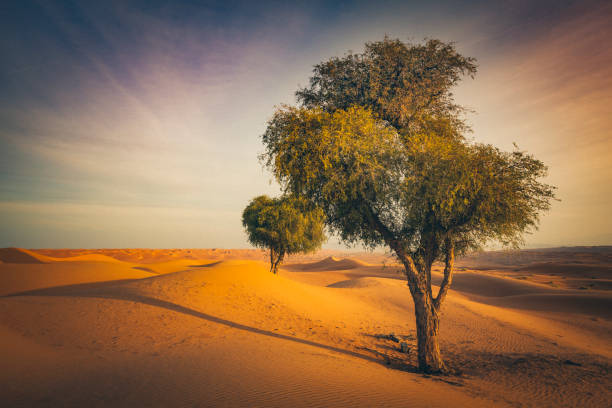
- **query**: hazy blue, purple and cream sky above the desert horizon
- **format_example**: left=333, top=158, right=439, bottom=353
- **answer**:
left=0, top=0, right=612, bottom=248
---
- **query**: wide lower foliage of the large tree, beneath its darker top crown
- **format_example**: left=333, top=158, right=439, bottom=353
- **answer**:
left=263, top=106, right=553, bottom=260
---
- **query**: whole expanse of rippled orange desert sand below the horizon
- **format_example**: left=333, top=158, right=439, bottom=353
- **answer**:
left=0, top=247, right=612, bottom=407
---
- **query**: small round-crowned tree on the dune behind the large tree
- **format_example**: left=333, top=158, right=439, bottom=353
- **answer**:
left=242, top=195, right=326, bottom=274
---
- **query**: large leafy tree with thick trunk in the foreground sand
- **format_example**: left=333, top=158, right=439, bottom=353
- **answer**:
left=262, top=38, right=554, bottom=373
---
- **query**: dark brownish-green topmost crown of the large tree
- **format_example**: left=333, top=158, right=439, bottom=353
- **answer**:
left=296, top=37, right=476, bottom=134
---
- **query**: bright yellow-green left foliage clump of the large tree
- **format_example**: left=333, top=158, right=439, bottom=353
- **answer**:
left=263, top=107, right=402, bottom=245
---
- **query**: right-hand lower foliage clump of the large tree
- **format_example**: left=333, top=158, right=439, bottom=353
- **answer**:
left=402, top=134, right=554, bottom=255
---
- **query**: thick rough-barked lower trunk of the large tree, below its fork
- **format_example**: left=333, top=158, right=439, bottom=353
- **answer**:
left=411, top=289, right=447, bottom=374
